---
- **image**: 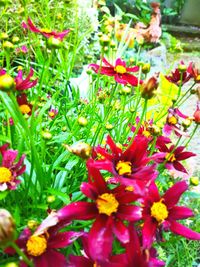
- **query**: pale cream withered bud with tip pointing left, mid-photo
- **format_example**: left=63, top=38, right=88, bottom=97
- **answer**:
left=64, top=142, right=92, bottom=159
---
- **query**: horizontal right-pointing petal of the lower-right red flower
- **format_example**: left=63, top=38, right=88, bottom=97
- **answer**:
left=168, top=206, right=194, bottom=220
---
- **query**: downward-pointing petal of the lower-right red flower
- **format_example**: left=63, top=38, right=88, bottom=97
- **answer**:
left=142, top=216, right=157, bottom=248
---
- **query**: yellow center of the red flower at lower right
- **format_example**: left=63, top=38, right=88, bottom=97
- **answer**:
left=151, top=199, right=168, bottom=223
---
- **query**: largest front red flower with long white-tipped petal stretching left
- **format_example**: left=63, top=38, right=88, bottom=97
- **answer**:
left=36, top=167, right=141, bottom=262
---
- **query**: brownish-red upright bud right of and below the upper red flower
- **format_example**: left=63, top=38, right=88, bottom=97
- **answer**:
left=140, top=77, right=158, bottom=99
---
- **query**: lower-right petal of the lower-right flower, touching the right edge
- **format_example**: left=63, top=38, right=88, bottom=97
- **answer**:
left=170, top=221, right=200, bottom=240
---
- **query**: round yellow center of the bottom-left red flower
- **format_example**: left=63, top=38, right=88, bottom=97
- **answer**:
left=26, top=235, right=47, bottom=257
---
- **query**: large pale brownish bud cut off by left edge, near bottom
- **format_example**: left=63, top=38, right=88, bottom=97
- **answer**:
left=0, top=209, right=15, bottom=247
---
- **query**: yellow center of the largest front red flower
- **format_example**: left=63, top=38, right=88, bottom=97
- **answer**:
left=96, top=193, right=119, bottom=216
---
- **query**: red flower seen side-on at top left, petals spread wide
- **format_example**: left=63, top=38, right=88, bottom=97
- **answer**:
left=22, top=18, right=70, bottom=41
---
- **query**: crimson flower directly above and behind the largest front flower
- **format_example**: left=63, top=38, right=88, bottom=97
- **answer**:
left=88, top=136, right=157, bottom=194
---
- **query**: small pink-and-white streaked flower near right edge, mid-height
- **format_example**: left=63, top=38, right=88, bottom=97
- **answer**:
left=163, top=108, right=190, bottom=137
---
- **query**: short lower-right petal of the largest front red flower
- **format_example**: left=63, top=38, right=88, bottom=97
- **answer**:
left=112, top=220, right=129, bottom=244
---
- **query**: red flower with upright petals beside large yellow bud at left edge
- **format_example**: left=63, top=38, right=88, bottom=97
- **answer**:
left=15, top=68, right=38, bottom=91
